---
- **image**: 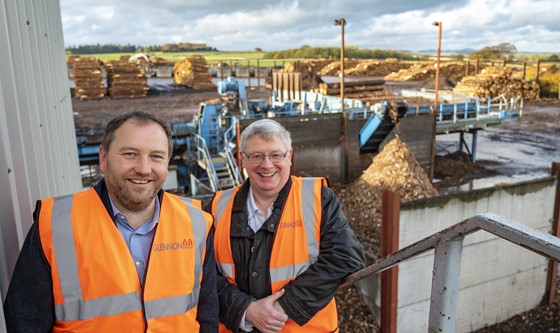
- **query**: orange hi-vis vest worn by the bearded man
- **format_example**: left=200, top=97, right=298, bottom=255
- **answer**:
left=38, top=188, right=212, bottom=333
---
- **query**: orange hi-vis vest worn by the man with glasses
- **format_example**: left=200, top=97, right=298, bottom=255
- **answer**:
left=212, top=176, right=338, bottom=333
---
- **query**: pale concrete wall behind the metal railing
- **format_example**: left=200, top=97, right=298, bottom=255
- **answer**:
left=397, top=178, right=557, bottom=333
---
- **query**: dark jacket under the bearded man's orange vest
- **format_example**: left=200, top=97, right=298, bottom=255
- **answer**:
left=4, top=180, right=218, bottom=333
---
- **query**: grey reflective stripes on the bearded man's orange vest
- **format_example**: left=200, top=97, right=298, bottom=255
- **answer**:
left=51, top=189, right=207, bottom=322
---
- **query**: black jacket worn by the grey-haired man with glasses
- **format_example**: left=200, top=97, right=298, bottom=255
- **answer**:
left=206, top=179, right=365, bottom=332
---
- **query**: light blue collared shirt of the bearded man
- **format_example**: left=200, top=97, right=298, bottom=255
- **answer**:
left=109, top=197, right=160, bottom=285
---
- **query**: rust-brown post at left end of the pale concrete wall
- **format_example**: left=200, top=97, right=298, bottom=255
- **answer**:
left=380, top=190, right=401, bottom=333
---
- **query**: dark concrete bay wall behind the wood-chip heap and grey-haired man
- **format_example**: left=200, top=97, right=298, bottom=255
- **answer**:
left=240, top=113, right=433, bottom=183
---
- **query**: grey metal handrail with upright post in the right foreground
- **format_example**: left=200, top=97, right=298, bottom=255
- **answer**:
left=340, top=213, right=560, bottom=333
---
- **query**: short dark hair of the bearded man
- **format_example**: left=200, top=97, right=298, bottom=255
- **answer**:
left=101, top=111, right=173, bottom=158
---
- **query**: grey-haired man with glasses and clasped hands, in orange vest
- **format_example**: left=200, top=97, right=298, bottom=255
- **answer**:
left=207, top=119, right=364, bottom=332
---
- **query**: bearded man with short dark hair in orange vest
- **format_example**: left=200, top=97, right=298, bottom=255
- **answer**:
left=4, top=112, right=218, bottom=332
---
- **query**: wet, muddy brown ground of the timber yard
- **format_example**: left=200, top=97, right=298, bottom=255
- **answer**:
left=72, top=82, right=560, bottom=333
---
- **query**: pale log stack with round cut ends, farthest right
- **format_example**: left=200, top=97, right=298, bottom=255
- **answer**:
left=453, top=67, right=540, bottom=100
